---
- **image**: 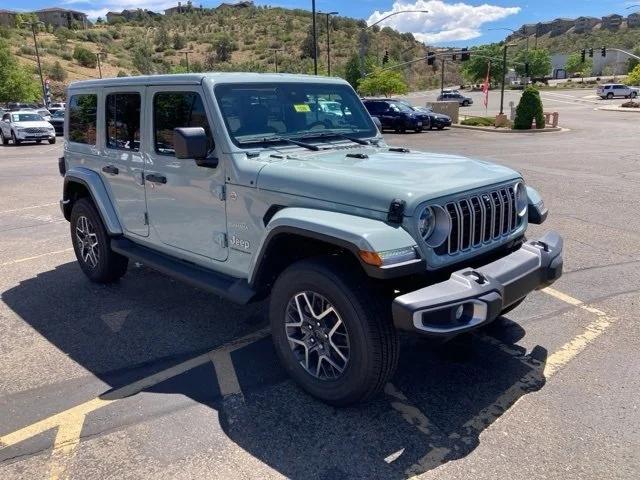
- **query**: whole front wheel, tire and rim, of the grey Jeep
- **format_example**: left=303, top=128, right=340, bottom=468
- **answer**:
left=269, top=256, right=399, bottom=406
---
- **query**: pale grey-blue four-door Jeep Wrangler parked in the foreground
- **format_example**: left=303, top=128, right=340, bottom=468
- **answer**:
left=59, top=73, right=563, bottom=405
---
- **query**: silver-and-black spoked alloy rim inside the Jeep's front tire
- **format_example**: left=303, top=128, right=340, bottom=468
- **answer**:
left=284, top=291, right=350, bottom=380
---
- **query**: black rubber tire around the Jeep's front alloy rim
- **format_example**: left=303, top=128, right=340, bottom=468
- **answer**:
left=269, top=256, right=399, bottom=406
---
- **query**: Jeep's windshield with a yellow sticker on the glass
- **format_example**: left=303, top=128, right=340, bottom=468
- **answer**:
left=215, top=82, right=377, bottom=146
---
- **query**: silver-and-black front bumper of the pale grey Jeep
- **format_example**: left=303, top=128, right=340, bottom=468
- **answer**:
left=392, top=232, right=563, bottom=337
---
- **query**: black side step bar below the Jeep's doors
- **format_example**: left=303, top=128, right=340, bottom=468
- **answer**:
left=111, top=237, right=256, bottom=305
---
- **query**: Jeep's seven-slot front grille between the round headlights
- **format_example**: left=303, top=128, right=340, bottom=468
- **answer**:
left=436, top=186, right=522, bottom=255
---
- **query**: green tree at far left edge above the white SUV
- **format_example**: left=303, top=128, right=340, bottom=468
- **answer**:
left=0, top=39, right=42, bottom=102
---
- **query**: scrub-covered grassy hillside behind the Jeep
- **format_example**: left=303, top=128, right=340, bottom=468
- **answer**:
left=0, top=7, right=459, bottom=98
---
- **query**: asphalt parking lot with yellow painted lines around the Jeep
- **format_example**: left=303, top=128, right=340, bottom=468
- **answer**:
left=0, top=91, right=640, bottom=480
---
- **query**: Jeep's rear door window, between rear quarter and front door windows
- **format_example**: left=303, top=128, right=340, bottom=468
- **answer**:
left=105, top=93, right=140, bottom=152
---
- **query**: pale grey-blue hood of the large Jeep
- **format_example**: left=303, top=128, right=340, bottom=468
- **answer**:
left=257, top=148, right=520, bottom=216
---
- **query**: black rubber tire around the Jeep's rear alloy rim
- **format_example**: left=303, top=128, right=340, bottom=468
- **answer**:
left=70, top=198, right=129, bottom=283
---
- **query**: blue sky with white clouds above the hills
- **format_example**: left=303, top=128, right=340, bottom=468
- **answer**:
left=10, top=0, right=640, bottom=47
